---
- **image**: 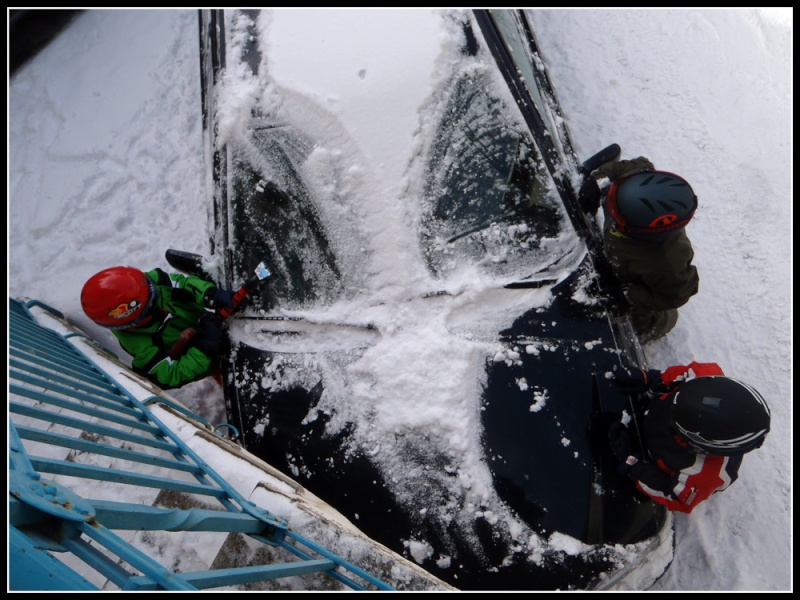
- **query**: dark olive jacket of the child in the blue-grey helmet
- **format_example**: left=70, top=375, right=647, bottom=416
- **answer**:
left=593, top=156, right=700, bottom=341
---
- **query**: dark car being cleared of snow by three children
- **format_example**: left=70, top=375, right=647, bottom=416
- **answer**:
left=201, top=10, right=672, bottom=590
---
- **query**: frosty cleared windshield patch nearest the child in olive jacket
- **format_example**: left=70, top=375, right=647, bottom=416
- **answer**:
left=421, top=73, right=576, bottom=280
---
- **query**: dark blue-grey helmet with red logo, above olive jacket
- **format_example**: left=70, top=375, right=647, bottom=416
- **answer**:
left=606, top=171, right=697, bottom=239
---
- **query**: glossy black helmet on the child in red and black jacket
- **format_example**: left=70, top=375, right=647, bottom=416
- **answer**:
left=670, top=377, right=770, bottom=456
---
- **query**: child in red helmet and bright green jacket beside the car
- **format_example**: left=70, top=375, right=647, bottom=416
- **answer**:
left=81, top=267, right=235, bottom=389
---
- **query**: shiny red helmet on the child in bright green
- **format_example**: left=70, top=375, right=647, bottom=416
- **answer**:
left=81, top=267, right=156, bottom=329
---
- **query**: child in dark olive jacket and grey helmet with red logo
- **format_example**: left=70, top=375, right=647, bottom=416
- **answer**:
left=580, top=156, right=700, bottom=343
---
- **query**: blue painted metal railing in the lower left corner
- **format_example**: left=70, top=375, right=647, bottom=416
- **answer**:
left=9, top=299, right=393, bottom=590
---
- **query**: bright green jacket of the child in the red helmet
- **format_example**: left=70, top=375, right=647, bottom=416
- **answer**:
left=112, top=269, right=219, bottom=389
